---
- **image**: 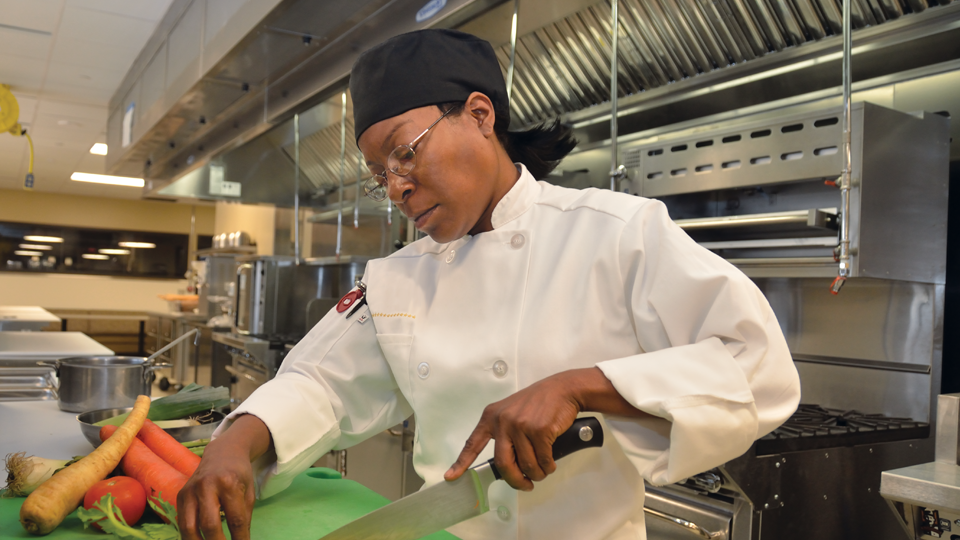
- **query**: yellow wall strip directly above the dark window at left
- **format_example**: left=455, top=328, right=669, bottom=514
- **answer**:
left=0, top=189, right=215, bottom=235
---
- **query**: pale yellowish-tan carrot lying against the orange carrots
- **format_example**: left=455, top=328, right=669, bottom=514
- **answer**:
left=20, top=396, right=150, bottom=535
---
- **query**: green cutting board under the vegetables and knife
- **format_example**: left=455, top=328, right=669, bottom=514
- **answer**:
left=0, top=468, right=456, bottom=540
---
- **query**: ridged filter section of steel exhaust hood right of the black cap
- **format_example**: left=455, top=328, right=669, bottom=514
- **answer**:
left=498, top=0, right=960, bottom=132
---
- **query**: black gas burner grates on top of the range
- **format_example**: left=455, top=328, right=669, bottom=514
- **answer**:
left=757, top=404, right=930, bottom=455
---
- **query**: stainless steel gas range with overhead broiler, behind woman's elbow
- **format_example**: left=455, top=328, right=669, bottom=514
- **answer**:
left=557, top=102, right=948, bottom=540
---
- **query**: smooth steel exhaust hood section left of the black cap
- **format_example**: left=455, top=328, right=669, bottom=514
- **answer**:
left=107, top=0, right=496, bottom=192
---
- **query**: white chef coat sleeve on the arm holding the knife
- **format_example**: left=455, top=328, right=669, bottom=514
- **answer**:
left=597, top=201, right=800, bottom=484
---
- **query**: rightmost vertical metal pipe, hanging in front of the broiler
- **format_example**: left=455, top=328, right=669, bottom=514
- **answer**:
left=830, top=2, right=853, bottom=294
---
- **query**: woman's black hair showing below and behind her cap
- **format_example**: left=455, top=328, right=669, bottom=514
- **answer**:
left=437, top=101, right=577, bottom=180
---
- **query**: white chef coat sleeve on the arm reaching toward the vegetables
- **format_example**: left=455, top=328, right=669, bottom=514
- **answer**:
left=214, top=300, right=412, bottom=498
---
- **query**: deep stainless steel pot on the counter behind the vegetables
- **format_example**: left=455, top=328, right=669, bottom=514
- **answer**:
left=43, top=356, right=172, bottom=412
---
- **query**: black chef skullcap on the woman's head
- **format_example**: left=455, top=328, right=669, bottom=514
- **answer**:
left=350, top=30, right=510, bottom=141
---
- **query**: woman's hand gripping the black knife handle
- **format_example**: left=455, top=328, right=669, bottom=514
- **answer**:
left=444, top=371, right=576, bottom=491
